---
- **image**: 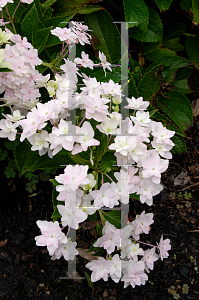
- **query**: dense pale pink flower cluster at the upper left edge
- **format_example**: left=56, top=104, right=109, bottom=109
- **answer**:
left=0, top=29, right=42, bottom=109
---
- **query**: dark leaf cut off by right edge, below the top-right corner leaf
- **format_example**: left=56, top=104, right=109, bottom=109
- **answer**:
left=185, top=36, right=199, bottom=65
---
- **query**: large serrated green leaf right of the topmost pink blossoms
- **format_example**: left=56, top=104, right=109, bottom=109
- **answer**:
left=85, top=10, right=121, bottom=63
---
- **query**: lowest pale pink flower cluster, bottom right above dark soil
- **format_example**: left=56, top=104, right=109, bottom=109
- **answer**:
left=86, top=218, right=171, bottom=288
